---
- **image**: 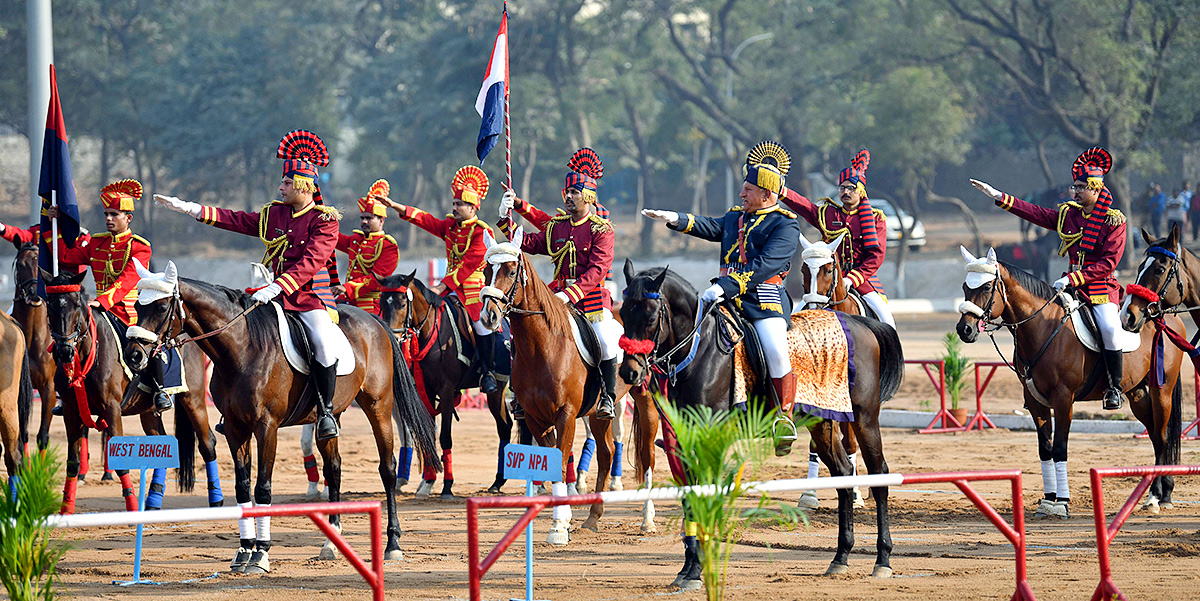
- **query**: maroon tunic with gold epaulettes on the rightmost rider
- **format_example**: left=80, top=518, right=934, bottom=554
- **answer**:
left=996, top=194, right=1127, bottom=305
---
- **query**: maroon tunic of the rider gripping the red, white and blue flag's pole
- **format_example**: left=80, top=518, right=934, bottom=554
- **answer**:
left=499, top=208, right=616, bottom=321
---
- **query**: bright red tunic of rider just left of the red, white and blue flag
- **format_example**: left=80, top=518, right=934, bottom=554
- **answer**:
left=400, top=206, right=492, bottom=320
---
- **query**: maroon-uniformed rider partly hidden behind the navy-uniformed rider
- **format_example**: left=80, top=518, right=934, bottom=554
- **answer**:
left=780, top=149, right=896, bottom=327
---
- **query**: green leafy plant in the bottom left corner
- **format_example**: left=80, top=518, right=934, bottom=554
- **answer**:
left=0, top=449, right=67, bottom=601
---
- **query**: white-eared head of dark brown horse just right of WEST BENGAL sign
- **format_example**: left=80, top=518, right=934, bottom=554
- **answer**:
left=125, top=259, right=184, bottom=372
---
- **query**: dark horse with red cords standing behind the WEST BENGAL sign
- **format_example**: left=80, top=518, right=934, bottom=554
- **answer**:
left=41, top=265, right=220, bottom=513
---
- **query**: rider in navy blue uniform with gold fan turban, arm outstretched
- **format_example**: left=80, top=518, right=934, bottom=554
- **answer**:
left=642, top=140, right=800, bottom=455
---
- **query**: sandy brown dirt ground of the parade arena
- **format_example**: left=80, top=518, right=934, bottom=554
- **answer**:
left=44, top=315, right=1200, bottom=601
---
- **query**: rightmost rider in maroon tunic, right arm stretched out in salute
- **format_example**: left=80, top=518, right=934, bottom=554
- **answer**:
left=971, top=146, right=1127, bottom=410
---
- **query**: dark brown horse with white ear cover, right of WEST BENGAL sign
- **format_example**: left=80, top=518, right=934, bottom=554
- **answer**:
left=128, top=263, right=440, bottom=575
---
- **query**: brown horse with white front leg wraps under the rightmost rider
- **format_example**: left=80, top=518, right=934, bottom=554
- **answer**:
left=956, top=248, right=1183, bottom=519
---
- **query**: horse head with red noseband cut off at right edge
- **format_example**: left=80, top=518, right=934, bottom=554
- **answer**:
left=1120, top=226, right=1192, bottom=332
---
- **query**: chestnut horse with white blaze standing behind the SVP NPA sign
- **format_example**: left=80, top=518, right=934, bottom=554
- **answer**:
left=480, top=228, right=654, bottom=545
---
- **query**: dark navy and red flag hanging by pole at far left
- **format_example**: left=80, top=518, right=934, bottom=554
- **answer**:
left=37, top=65, right=79, bottom=271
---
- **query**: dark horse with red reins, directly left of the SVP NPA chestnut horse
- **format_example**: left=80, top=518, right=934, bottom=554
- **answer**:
left=379, top=271, right=512, bottom=499
